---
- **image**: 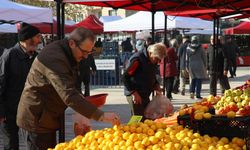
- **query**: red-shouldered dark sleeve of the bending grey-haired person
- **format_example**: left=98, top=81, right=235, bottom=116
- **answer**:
left=123, top=59, right=139, bottom=94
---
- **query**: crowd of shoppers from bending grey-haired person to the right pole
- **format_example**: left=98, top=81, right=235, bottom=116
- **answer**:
left=123, top=33, right=239, bottom=119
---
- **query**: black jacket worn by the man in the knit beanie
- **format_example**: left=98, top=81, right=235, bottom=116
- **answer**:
left=0, top=43, right=37, bottom=117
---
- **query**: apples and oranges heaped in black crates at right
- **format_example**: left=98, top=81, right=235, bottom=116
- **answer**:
left=178, top=80, right=250, bottom=144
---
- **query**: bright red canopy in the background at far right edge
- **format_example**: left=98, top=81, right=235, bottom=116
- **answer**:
left=224, top=22, right=250, bottom=35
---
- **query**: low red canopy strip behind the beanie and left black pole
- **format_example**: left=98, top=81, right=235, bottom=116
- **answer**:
left=28, top=20, right=76, bottom=34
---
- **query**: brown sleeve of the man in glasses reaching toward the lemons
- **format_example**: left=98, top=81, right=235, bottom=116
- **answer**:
left=45, top=59, right=104, bottom=120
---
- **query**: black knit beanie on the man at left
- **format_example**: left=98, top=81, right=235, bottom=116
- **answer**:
left=18, top=22, right=40, bottom=41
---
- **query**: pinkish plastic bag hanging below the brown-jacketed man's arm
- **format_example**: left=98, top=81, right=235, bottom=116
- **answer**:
left=72, top=112, right=91, bottom=136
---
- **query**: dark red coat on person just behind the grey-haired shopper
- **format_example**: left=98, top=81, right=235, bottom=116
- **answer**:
left=160, top=48, right=178, bottom=77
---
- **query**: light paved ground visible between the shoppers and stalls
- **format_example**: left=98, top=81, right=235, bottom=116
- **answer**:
left=0, top=67, right=250, bottom=150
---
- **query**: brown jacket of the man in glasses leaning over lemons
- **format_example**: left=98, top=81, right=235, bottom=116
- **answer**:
left=17, top=39, right=103, bottom=133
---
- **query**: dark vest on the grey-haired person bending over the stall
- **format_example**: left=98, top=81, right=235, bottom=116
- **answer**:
left=123, top=49, right=158, bottom=97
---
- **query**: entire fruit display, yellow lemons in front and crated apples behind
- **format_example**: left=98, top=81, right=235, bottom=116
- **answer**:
left=49, top=79, right=250, bottom=150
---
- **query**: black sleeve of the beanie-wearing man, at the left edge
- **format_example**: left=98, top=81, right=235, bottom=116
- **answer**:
left=0, top=50, right=9, bottom=117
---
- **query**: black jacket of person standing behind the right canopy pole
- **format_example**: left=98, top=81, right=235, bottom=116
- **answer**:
left=207, top=44, right=229, bottom=74
